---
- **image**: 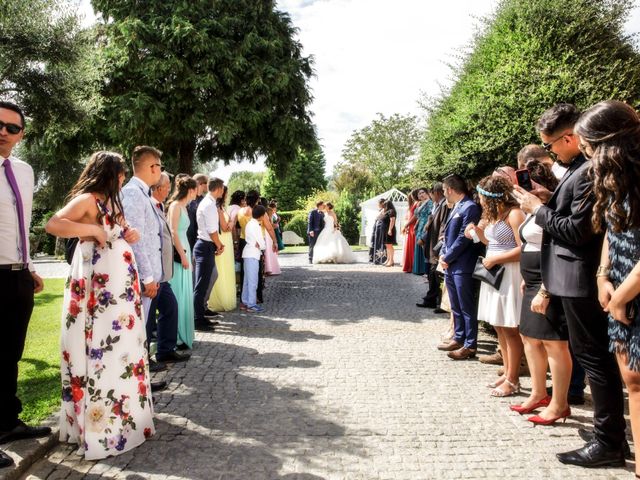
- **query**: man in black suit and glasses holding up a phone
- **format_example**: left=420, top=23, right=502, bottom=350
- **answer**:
left=514, top=104, right=626, bottom=467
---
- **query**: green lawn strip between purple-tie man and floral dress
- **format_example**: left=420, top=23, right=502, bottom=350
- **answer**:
left=18, top=278, right=64, bottom=424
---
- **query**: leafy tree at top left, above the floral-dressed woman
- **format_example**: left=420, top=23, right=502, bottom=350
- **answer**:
left=0, top=0, right=102, bottom=206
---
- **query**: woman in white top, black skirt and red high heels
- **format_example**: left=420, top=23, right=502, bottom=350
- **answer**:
left=511, top=160, right=572, bottom=423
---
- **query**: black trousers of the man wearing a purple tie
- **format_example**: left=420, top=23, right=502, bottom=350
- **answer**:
left=0, top=270, right=34, bottom=431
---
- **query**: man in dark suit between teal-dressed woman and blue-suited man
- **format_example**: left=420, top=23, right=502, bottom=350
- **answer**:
left=416, top=182, right=449, bottom=309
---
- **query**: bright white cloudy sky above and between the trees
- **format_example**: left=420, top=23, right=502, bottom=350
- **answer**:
left=77, top=0, right=640, bottom=177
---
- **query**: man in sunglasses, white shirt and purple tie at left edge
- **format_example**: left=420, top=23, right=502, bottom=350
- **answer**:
left=0, top=102, right=51, bottom=467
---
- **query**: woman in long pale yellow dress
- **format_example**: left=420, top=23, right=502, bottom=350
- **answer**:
left=209, top=186, right=237, bottom=312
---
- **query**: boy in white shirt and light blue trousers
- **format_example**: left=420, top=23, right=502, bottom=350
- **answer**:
left=240, top=205, right=267, bottom=313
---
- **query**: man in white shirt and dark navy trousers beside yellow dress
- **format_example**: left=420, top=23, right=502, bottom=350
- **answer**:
left=193, top=178, right=225, bottom=331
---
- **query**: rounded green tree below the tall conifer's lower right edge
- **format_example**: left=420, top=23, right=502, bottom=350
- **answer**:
left=262, top=147, right=327, bottom=210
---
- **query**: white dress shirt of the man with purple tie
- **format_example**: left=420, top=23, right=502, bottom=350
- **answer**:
left=0, top=156, right=34, bottom=271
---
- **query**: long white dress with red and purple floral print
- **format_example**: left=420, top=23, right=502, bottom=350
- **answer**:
left=60, top=199, right=155, bottom=460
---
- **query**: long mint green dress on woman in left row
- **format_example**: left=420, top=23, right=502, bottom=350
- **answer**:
left=169, top=207, right=194, bottom=348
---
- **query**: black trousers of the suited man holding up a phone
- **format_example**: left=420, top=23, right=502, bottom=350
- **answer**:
left=562, top=297, right=626, bottom=449
